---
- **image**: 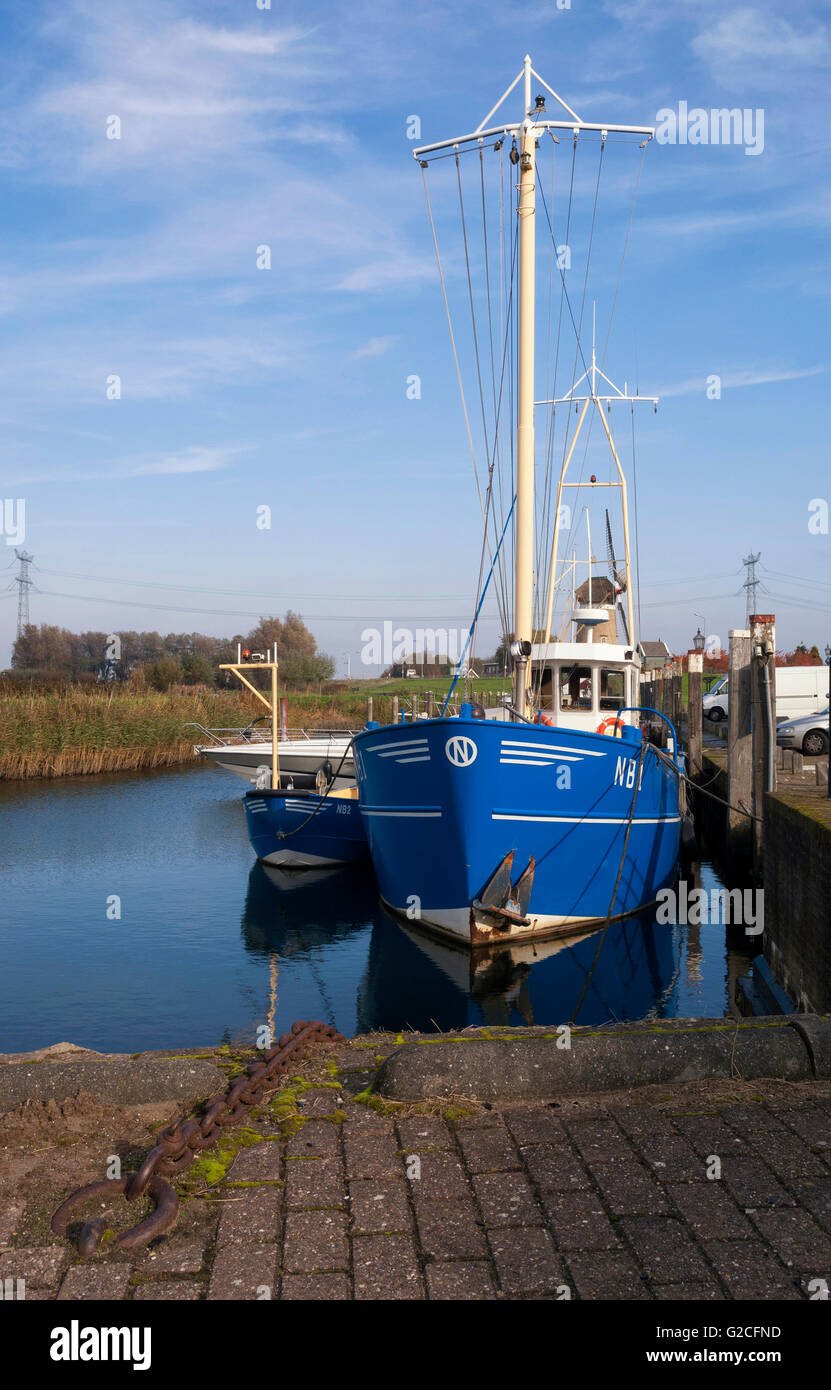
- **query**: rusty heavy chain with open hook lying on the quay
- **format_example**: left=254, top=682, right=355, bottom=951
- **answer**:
left=51, top=1023, right=343, bottom=1255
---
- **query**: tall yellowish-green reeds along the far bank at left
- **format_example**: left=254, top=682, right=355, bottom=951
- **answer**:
left=0, top=687, right=367, bottom=780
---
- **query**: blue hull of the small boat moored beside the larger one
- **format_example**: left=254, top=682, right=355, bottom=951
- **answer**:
left=243, top=787, right=370, bottom=869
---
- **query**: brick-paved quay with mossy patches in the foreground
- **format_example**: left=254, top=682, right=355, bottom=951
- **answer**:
left=0, top=1036, right=831, bottom=1301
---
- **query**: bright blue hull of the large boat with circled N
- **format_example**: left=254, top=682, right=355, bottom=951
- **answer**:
left=354, top=717, right=681, bottom=945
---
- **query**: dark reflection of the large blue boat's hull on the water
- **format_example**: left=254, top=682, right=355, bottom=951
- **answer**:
left=359, top=908, right=680, bottom=1031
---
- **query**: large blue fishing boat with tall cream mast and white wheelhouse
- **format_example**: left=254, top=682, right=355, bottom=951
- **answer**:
left=354, top=58, right=684, bottom=947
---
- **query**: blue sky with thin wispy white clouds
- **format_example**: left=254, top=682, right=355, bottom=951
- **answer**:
left=0, top=0, right=831, bottom=671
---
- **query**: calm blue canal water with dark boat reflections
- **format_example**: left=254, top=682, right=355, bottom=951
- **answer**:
left=0, top=767, right=755, bottom=1052
